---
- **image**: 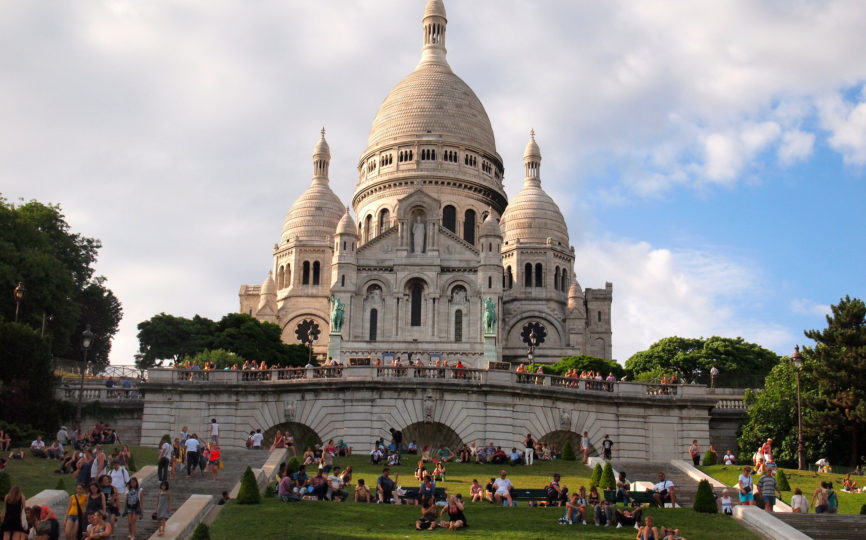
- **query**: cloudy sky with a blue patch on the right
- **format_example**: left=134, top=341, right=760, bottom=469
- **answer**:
left=0, top=0, right=866, bottom=364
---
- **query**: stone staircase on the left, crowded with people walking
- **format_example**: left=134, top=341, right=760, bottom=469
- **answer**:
left=104, top=449, right=268, bottom=539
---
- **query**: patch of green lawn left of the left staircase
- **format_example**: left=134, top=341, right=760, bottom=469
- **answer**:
left=0, top=445, right=157, bottom=505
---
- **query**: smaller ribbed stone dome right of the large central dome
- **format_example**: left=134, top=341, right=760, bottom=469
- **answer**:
left=499, top=179, right=568, bottom=247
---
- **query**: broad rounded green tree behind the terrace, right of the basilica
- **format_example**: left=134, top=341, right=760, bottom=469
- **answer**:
left=625, top=336, right=779, bottom=386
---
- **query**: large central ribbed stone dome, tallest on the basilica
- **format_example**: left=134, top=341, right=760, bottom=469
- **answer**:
left=365, top=63, right=496, bottom=155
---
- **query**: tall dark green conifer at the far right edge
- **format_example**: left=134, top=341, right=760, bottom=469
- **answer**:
left=803, top=296, right=866, bottom=467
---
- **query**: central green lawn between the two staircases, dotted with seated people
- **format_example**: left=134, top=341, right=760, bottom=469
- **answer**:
left=211, top=456, right=758, bottom=540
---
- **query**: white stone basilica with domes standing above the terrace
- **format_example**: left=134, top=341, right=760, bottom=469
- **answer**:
left=239, top=0, right=613, bottom=367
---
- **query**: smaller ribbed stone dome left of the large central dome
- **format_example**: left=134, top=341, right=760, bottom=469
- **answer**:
left=280, top=178, right=345, bottom=242
